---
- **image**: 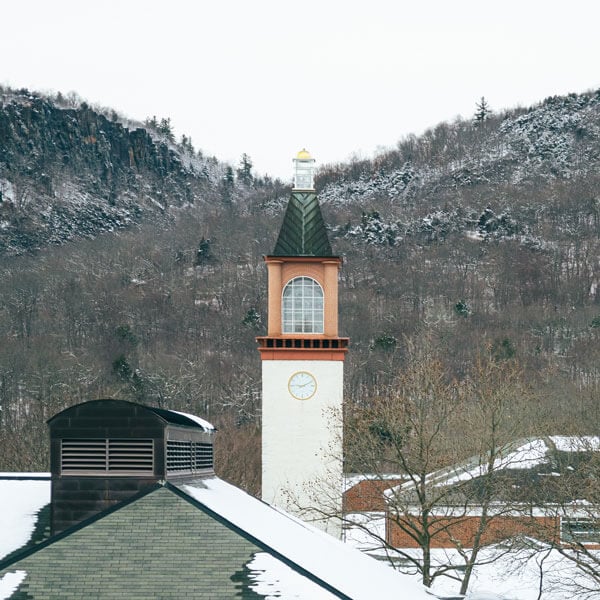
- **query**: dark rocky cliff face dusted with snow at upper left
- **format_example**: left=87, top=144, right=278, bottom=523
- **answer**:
left=0, top=91, right=223, bottom=254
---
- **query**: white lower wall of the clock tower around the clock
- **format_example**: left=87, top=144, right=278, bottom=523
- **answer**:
left=262, top=360, right=344, bottom=537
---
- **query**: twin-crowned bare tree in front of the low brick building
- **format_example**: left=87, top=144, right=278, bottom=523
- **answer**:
left=338, top=339, right=531, bottom=594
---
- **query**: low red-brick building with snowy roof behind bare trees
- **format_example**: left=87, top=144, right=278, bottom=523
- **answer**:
left=384, top=436, right=600, bottom=549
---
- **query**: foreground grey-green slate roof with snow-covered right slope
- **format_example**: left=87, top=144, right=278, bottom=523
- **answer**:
left=0, top=477, right=430, bottom=600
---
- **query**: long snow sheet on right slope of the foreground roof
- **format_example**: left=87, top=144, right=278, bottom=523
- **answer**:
left=178, top=477, right=430, bottom=600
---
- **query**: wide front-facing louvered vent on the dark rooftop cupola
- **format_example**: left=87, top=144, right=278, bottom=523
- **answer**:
left=61, top=439, right=154, bottom=475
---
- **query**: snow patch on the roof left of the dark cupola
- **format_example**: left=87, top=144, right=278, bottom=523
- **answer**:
left=0, top=473, right=50, bottom=559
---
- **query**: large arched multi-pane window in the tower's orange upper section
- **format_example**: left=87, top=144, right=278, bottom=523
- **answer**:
left=282, top=277, right=323, bottom=333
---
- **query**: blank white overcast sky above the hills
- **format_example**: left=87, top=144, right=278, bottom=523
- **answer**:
left=0, top=0, right=600, bottom=180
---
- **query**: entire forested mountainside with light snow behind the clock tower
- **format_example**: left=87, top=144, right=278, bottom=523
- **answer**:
left=0, top=90, right=600, bottom=491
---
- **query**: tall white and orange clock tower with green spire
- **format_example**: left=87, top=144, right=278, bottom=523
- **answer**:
left=257, top=150, right=348, bottom=536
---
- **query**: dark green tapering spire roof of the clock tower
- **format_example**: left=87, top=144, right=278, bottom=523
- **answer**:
left=273, top=190, right=333, bottom=256
